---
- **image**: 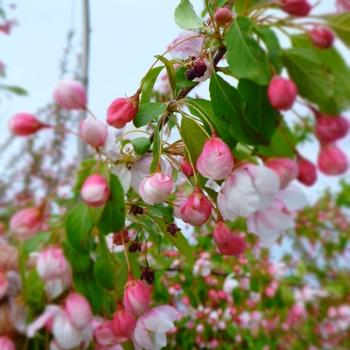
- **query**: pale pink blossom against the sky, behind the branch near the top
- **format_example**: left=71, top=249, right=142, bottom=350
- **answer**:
left=168, top=30, right=204, bottom=60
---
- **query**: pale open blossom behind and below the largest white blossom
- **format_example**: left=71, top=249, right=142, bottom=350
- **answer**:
left=247, top=185, right=307, bottom=247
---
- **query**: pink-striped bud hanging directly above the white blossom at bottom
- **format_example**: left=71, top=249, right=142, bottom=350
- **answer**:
left=124, top=277, right=151, bottom=316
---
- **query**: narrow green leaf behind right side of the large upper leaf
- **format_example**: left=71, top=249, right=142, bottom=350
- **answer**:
left=255, top=28, right=283, bottom=73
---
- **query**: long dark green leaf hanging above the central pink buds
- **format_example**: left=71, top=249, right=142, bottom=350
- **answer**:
left=209, top=73, right=266, bottom=145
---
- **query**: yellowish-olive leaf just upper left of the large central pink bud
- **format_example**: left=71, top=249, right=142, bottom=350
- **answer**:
left=181, top=117, right=208, bottom=164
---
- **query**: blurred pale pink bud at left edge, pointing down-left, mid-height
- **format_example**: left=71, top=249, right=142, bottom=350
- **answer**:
left=10, top=207, right=44, bottom=239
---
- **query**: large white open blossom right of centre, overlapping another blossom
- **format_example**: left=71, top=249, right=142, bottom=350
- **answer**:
left=217, top=163, right=280, bottom=221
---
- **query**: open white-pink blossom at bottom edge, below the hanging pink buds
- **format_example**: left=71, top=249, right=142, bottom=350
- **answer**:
left=133, top=305, right=178, bottom=350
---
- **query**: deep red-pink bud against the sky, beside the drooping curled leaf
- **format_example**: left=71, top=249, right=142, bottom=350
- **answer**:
left=107, top=95, right=139, bottom=129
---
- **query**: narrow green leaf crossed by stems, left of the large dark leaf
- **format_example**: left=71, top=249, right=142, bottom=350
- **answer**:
left=186, top=98, right=237, bottom=148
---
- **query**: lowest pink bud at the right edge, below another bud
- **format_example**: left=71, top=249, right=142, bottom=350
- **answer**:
left=317, top=144, right=349, bottom=175
